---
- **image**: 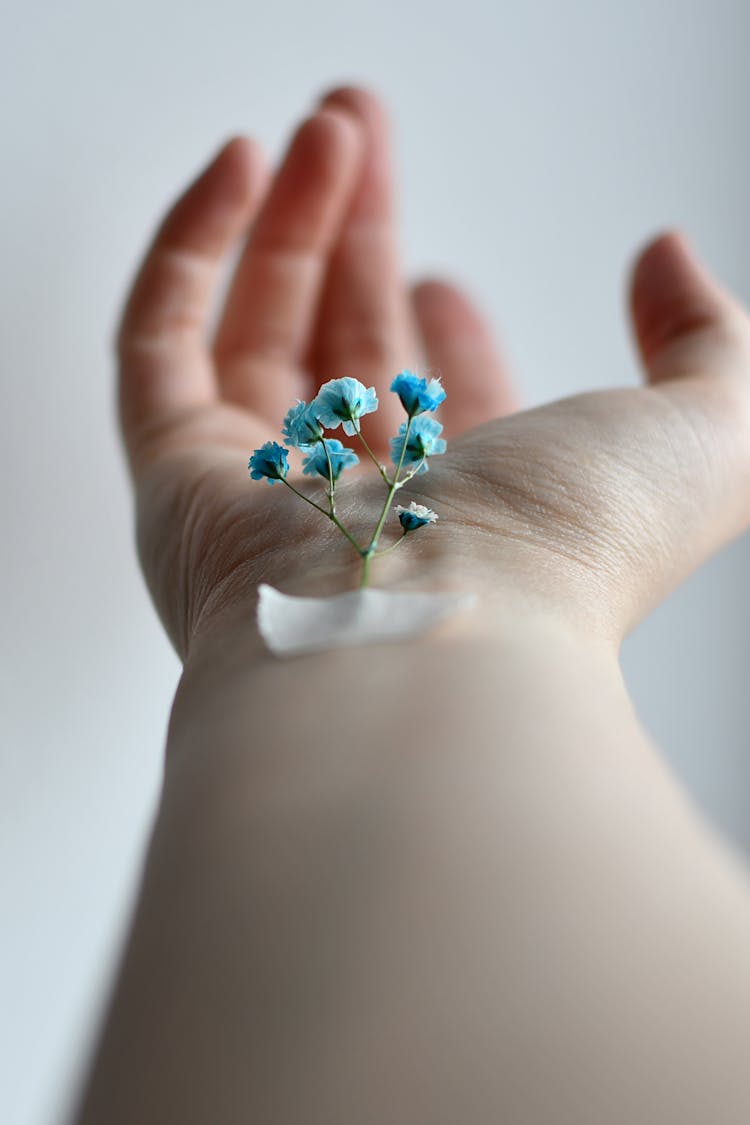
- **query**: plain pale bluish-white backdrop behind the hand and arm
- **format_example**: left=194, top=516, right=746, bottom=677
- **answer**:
left=0, top=0, right=750, bottom=1125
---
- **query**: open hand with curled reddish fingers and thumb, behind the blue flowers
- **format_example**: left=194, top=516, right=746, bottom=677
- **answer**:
left=118, top=89, right=750, bottom=656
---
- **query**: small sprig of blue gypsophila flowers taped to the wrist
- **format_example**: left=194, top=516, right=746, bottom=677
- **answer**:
left=247, top=370, right=445, bottom=586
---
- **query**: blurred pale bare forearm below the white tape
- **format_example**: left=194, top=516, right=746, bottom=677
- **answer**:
left=73, top=608, right=750, bottom=1125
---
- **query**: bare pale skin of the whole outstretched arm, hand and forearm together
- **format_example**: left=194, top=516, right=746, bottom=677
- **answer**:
left=75, top=88, right=750, bottom=1125
